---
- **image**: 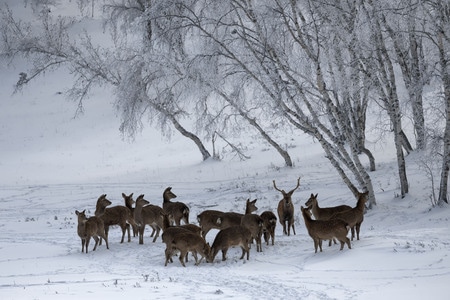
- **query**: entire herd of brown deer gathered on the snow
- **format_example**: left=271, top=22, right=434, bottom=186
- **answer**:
left=75, top=178, right=368, bottom=266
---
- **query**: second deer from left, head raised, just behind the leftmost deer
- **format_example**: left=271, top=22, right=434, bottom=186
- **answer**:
left=95, top=194, right=135, bottom=244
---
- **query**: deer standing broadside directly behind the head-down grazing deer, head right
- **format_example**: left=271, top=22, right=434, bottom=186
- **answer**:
left=197, top=200, right=258, bottom=238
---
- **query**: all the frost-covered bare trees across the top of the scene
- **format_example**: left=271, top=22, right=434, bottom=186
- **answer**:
left=0, top=0, right=450, bottom=206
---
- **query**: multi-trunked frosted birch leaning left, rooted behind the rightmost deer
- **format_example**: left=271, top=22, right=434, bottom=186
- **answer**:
left=164, top=1, right=375, bottom=205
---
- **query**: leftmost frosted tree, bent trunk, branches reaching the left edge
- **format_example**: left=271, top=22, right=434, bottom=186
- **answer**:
left=1, top=1, right=211, bottom=160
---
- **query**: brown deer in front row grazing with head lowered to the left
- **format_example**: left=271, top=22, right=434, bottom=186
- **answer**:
left=208, top=225, right=251, bottom=262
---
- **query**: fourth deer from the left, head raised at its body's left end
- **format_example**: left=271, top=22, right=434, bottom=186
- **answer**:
left=134, top=194, right=170, bottom=245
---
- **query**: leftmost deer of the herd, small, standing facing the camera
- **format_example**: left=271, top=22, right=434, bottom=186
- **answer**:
left=75, top=210, right=109, bottom=254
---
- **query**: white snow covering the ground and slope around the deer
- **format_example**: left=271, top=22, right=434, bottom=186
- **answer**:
left=0, top=2, right=450, bottom=299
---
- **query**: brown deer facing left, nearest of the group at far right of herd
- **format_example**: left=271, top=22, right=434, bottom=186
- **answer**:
left=301, top=206, right=352, bottom=253
